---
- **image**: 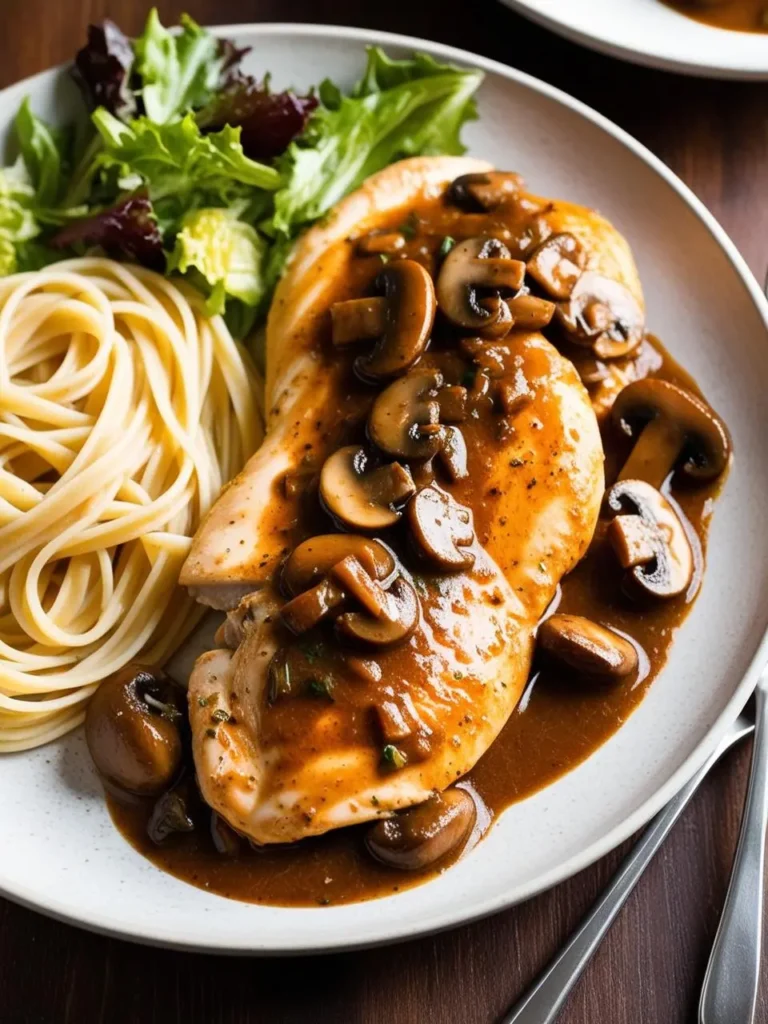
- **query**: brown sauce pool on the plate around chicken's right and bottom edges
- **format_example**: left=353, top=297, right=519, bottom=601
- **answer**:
left=109, top=337, right=722, bottom=906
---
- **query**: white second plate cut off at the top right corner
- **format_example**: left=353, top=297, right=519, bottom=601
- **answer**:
left=502, top=0, right=768, bottom=79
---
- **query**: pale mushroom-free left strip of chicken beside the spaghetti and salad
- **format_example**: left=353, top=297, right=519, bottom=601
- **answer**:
left=179, top=157, right=490, bottom=609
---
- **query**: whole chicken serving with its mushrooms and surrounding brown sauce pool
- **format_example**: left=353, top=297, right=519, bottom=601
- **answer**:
left=91, top=158, right=730, bottom=902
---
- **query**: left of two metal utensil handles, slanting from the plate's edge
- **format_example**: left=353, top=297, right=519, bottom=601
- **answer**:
left=499, top=720, right=751, bottom=1024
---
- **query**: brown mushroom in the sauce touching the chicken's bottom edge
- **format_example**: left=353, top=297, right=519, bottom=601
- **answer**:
left=366, top=788, right=476, bottom=871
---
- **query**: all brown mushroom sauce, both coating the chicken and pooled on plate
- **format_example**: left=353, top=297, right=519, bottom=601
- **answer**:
left=109, top=174, right=722, bottom=906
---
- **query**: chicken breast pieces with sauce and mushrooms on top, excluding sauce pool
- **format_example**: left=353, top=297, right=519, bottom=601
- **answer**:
left=182, top=159, right=614, bottom=844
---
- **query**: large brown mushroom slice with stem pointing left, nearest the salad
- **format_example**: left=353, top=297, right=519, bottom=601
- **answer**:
left=331, top=259, right=436, bottom=382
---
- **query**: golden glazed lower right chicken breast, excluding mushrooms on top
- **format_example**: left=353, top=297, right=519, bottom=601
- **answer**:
left=189, top=325, right=603, bottom=844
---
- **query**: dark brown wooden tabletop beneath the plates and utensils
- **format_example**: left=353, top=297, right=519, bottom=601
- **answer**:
left=0, top=0, right=768, bottom=1024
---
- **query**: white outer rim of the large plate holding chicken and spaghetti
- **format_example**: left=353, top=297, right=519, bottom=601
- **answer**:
left=0, top=22, right=768, bottom=955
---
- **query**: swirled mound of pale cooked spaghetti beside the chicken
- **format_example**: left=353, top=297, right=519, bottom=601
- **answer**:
left=0, top=258, right=261, bottom=752
